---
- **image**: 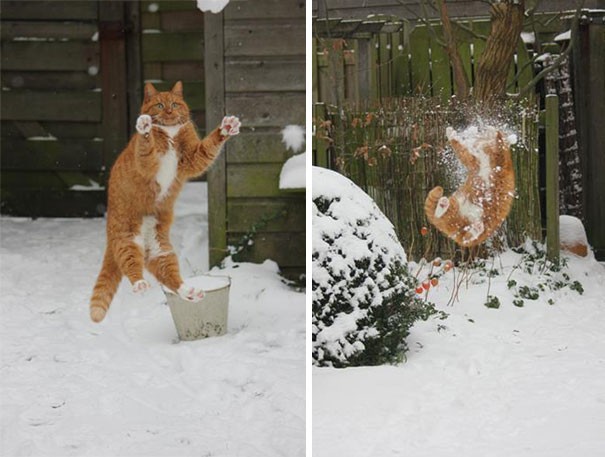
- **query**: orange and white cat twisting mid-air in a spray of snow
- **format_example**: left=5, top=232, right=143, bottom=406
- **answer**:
left=424, top=128, right=515, bottom=247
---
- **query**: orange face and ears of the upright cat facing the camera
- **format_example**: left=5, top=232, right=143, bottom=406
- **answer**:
left=141, top=81, right=189, bottom=125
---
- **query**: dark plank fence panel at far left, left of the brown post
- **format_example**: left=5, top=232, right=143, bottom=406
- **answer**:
left=1, top=1, right=108, bottom=216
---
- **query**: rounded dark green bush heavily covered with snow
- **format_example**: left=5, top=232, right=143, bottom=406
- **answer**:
left=313, top=167, right=434, bottom=367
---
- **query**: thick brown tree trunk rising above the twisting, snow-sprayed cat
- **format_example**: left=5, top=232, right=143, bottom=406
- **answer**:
left=474, top=0, right=525, bottom=107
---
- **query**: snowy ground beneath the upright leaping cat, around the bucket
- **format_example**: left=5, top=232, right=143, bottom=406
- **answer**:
left=0, top=184, right=305, bottom=457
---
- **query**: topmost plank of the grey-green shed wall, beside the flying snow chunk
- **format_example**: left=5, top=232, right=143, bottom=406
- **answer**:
left=225, top=0, right=305, bottom=21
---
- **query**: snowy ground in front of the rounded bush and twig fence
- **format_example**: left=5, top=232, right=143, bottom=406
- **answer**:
left=313, top=252, right=605, bottom=457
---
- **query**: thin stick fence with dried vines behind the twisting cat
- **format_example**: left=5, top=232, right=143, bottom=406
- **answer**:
left=316, top=97, right=542, bottom=260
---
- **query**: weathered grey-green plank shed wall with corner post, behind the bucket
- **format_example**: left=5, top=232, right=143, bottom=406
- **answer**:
left=205, top=0, right=305, bottom=274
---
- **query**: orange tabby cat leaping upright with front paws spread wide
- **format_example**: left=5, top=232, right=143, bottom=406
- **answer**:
left=90, top=81, right=240, bottom=322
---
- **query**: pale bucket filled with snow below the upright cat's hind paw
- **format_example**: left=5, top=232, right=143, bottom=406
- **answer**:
left=164, top=275, right=231, bottom=341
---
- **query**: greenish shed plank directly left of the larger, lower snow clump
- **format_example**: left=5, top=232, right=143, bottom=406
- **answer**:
left=227, top=163, right=284, bottom=198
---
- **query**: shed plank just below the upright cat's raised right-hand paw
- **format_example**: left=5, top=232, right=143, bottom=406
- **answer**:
left=227, top=131, right=292, bottom=164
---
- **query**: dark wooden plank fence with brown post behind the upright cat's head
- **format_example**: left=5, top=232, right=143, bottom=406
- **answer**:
left=1, top=0, right=205, bottom=217
